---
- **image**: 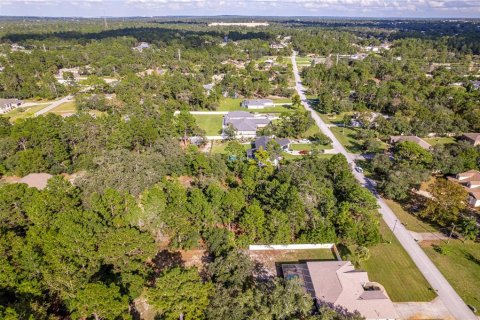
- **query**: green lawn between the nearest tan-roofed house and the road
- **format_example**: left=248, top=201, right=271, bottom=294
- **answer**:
left=361, top=220, right=436, bottom=302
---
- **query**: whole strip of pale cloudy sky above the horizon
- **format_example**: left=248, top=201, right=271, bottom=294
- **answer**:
left=0, top=0, right=480, bottom=18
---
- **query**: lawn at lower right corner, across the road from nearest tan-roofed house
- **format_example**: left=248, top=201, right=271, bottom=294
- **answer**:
left=424, top=240, right=480, bottom=315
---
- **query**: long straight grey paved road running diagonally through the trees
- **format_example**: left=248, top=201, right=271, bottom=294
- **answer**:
left=291, top=52, right=478, bottom=320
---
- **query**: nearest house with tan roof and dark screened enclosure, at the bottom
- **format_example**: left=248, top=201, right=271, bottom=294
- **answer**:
left=282, top=261, right=399, bottom=319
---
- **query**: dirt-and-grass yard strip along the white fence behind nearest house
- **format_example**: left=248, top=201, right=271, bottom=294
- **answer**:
left=249, top=249, right=337, bottom=276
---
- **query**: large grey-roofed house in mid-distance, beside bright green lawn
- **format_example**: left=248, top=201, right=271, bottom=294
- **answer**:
left=223, top=111, right=272, bottom=137
